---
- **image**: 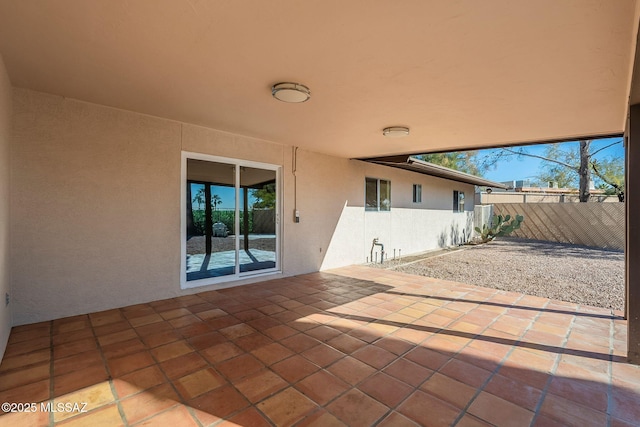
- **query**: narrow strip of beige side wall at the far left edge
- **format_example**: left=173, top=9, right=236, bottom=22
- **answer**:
left=0, top=56, right=12, bottom=358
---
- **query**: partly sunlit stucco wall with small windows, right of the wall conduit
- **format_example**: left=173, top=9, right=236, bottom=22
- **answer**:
left=285, top=150, right=474, bottom=270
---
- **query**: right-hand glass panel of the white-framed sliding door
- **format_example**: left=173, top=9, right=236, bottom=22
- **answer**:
left=238, top=167, right=277, bottom=273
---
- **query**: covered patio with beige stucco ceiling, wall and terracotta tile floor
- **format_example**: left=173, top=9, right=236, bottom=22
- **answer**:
left=0, top=0, right=640, bottom=427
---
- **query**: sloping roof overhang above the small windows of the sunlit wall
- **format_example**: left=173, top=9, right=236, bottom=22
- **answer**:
left=364, top=156, right=509, bottom=190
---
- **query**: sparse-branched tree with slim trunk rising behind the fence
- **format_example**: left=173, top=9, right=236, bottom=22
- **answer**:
left=495, top=140, right=624, bottom=202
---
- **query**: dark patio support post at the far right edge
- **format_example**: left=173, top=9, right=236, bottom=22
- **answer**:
left=625, top=104, right=640, bottom=365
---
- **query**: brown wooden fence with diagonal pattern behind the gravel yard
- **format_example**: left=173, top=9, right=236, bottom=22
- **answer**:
left=493, top=203, right=625, bottom=251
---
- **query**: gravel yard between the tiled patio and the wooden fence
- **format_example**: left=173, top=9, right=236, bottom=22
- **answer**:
left=378, top=238, right=624, bottom=310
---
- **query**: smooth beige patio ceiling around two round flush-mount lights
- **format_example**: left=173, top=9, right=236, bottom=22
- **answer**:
left=0, top=0, right=638, bottom=157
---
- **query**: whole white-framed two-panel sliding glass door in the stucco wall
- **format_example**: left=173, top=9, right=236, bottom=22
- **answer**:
left=183, top=153, right=279, bottom=287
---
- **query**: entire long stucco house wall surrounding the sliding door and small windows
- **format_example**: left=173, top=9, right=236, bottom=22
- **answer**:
left=10, top=89, right=473, bottom=325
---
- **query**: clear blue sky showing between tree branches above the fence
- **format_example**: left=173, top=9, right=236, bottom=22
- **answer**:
left=479, top=137, right=624, bottom=182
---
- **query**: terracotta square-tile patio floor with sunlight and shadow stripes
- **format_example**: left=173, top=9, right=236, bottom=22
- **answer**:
left=0, top=267, right=640, bottom=427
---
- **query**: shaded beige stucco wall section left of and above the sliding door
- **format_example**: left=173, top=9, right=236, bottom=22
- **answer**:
left=11, top=89, right=296, bottom=324
